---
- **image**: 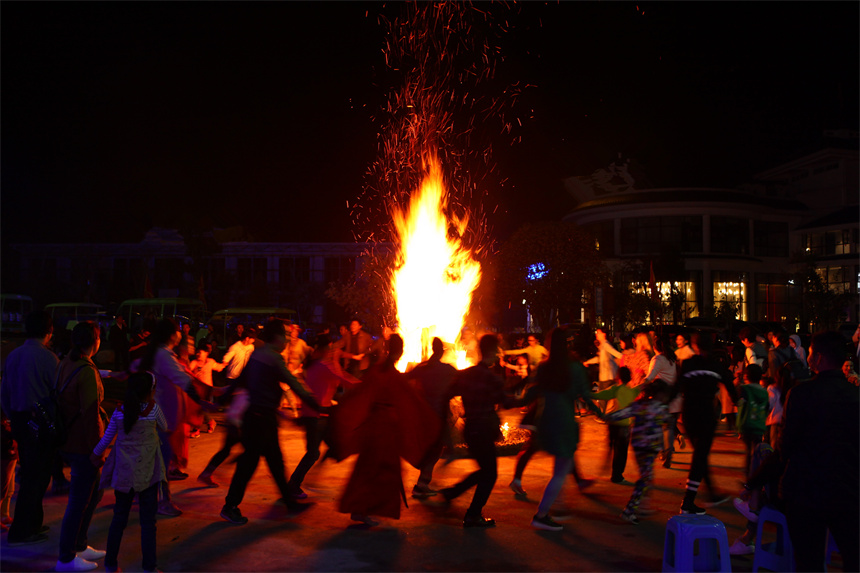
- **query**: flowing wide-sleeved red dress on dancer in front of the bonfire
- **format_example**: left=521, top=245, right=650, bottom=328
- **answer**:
left=331, top=365, right=440, bottom=519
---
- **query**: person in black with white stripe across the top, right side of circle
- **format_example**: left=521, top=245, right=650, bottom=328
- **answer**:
left=679, top=332, right=737, bottom=515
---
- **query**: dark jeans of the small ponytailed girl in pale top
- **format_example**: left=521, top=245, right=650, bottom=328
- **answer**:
left=105, top=484, right=158, bottom=571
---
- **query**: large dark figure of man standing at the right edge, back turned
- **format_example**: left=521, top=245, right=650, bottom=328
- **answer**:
left=781, top=332, right=860, bottom=571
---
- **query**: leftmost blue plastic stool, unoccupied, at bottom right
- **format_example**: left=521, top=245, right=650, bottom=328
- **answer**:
left=663, top=515, right=732, bottom=573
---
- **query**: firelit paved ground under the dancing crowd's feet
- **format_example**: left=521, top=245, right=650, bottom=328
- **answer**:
left=0, top=411, right=839, bottom=572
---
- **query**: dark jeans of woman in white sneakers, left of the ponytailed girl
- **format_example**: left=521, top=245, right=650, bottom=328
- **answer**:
left=60, top=452, right=103, bottom=563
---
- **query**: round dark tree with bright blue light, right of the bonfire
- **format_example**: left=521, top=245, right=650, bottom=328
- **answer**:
left=496, top=222, right=605, bottom=331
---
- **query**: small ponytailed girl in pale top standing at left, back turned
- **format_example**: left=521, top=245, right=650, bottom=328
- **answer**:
left=91, top=372, right=167, bottom=572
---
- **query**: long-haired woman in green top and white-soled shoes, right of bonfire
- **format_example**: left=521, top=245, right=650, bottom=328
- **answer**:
left=532, top=328, right=601, bottom=531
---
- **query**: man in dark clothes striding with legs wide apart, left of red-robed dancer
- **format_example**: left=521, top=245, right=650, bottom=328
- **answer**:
left=221, top=318, right=327, bottom=525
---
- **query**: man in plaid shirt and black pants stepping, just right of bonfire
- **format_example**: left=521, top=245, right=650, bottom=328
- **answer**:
left=440, top=334, right=517, bottom=527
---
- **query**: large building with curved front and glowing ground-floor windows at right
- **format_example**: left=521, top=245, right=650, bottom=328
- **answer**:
left=564, top=148, right=860, bottom=330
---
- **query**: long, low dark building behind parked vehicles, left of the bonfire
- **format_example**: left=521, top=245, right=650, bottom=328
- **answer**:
left=4, top=228, right=389, bottom=323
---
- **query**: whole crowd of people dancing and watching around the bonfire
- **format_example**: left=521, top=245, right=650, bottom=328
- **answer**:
left=0, top=311, right=860, bottom=571
